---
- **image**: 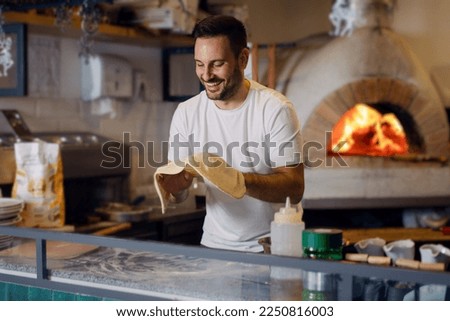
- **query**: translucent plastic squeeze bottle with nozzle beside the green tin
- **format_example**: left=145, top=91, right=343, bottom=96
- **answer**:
left=270, top=197, right=305, bottom=257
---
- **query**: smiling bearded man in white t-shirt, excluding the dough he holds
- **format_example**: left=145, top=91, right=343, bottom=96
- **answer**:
left=159, top=15, right=304, bottom=252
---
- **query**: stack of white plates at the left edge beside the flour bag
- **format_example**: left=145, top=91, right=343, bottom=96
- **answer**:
left=0, top=197, right=23, bottom=249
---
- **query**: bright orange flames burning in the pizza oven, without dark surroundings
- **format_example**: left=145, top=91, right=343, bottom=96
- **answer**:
left=331, top=104, right=409, bottom=156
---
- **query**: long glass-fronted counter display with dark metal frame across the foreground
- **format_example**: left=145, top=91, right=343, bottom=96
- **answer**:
left=0, top=225, right=450, bottom=301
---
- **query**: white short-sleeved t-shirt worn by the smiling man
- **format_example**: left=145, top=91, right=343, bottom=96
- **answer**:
left=169, top=81, right=302, bottom=252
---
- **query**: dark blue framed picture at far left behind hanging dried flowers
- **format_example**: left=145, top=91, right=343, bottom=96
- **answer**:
left=0, top=24, right=27, bottom=96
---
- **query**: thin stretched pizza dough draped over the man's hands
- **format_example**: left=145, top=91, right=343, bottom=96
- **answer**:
left=153, top=153, right=246, bottom=214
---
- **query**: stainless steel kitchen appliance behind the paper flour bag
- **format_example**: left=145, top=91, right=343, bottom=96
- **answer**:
left=0, top=110, right=131, bottom=225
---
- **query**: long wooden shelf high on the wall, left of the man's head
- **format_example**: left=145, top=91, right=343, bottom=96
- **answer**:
left=4, top=10, right=193, bottom=47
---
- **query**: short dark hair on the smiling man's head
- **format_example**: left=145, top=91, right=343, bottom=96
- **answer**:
left=192, top=15, right=247, bottom=57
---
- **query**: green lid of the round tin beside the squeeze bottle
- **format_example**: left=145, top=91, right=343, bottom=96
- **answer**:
left=302, top=228, right=342, bottom=251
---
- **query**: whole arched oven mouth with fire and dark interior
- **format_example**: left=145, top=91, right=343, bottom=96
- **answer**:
left=327, top=103, right=423, bottom=156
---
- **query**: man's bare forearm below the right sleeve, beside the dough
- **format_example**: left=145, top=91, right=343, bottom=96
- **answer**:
left=243, top=164, right=304, bottom=203
